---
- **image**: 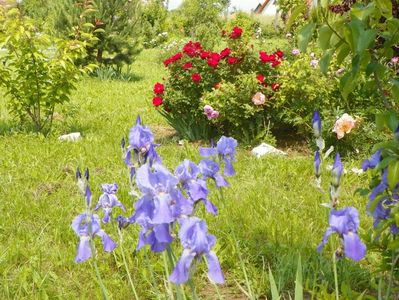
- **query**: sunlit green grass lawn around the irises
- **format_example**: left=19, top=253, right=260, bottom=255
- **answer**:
left=0, top=50, right=376, bottom=299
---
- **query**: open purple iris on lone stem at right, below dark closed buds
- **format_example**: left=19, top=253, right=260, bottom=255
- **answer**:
left=317, top=207, right=366, bottom=261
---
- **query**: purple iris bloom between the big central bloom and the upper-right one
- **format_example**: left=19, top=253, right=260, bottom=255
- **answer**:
left=175, top=159, right=217, bottom=215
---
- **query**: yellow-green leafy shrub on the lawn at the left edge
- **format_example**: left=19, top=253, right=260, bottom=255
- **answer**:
left=0, top=9, right=90, bottom=133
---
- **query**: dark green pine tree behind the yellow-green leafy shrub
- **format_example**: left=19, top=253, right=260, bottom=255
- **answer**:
left=54, top=0, right=142, bottom=66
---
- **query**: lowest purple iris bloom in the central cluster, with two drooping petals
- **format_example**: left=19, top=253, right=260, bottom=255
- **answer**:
left=169, top=217, right=224, bottom=284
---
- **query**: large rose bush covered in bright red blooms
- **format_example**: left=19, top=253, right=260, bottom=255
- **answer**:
left=153, top=26, right=284, bottom=142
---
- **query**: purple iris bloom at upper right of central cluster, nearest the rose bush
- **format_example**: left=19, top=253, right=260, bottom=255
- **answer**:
left=200, top=136, right=237, bottom=176
